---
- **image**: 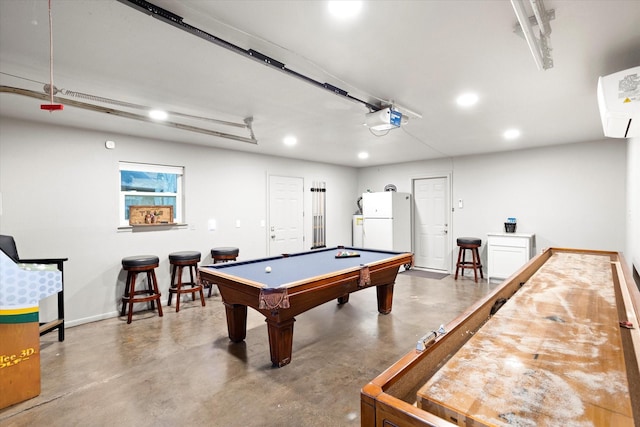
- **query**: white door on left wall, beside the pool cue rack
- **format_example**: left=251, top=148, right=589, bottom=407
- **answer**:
left=268, top=175, right=304, bottom=255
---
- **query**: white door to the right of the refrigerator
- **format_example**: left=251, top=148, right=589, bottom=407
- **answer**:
left=413, top=177, right=450, bottom=271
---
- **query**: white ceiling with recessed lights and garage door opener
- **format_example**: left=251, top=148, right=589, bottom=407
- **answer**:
left=0, top=0, right=640, bottom=167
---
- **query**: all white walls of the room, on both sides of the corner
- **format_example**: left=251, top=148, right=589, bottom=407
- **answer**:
left=0, top=118, right=640, bottom=326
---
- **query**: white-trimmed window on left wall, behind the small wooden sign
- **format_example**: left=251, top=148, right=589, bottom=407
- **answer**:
left=119, top=162, right=184, bottom=227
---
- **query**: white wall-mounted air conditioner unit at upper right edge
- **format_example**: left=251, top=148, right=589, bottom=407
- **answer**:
left=598, top=67, right=640, bottom=138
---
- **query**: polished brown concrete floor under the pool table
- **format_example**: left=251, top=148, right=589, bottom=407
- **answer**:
left=0, top=273, right=495, bottom=427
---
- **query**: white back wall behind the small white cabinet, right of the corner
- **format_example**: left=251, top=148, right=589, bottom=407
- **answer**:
left=358, top=139, right=627, bottom=265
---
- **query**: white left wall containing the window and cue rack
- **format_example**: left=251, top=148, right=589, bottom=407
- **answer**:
left=0, top=118, right=357, bottom=326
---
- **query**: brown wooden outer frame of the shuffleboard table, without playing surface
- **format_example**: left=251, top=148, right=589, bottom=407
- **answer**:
left=360, top=248, right=640, bottom=427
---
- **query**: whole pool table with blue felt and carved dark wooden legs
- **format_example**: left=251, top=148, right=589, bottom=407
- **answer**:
left=199, top=246, right=413, bottom=367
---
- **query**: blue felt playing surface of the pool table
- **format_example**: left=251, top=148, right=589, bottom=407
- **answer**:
left=204, top=247, right=408, bottom=288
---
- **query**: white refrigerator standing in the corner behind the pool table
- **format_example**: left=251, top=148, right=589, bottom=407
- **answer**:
left=362, top=191, right=411, bottom=252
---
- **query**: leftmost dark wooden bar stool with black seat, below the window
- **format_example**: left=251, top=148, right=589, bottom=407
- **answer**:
left=120, top=255, right=162, bottom=323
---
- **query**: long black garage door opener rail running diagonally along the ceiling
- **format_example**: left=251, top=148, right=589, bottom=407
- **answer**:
left=118, top=0, right=382, bottom=112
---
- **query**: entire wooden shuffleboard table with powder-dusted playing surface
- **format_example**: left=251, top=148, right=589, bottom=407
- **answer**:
left=361, top=248, right=640, bottom=427
